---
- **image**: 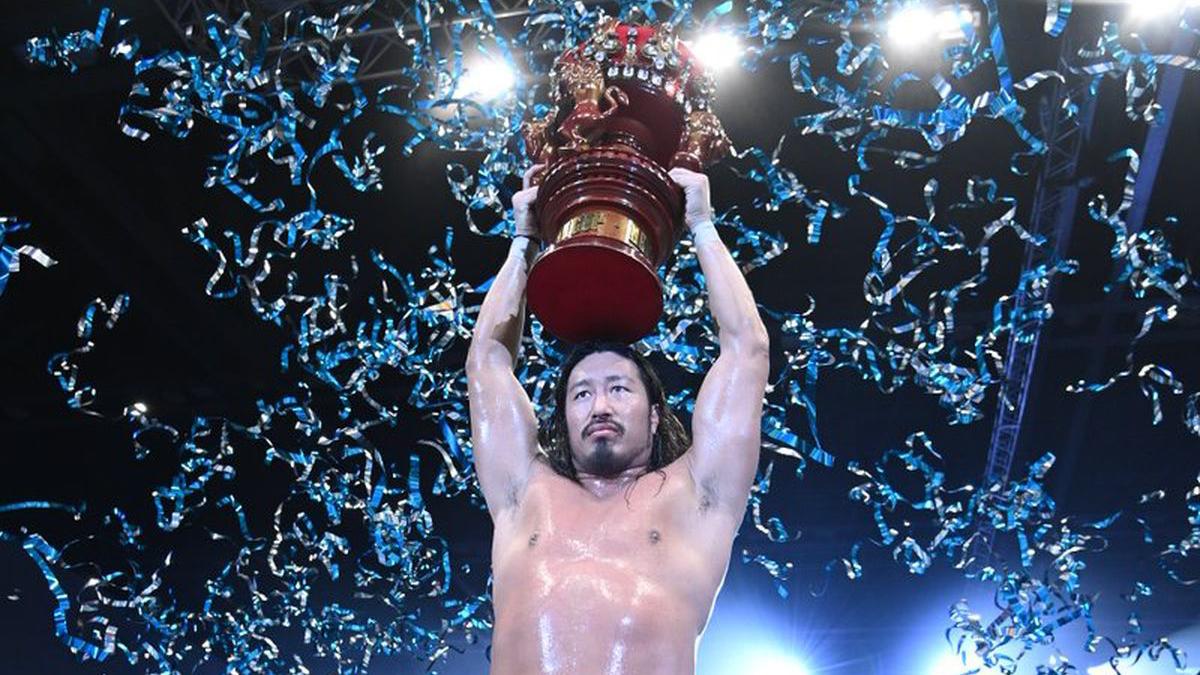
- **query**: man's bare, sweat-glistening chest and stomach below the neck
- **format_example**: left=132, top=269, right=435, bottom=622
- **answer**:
left=492, top=458, right=740, bottom=675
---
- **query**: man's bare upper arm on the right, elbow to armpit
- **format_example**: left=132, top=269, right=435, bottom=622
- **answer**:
left=689, top=353, right=769, bottom=513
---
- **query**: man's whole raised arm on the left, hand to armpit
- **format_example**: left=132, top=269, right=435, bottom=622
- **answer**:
left=467, top=167, right=538, bottom=520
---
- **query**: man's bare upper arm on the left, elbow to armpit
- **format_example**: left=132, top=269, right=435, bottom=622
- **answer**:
left=467, top=366, right=538, bottom=515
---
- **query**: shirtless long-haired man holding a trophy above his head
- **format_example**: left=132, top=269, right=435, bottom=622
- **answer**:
left=467, top=167, right=768, bottom=675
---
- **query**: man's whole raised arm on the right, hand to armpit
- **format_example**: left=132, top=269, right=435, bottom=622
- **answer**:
left=671, top=168, right=770, bottom=514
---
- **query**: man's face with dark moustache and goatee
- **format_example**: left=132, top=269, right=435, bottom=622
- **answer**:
left=566, top=352, right=659, bottom=476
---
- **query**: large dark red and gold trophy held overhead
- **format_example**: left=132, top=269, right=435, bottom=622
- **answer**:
left=522, top=14, right=731, bottom=342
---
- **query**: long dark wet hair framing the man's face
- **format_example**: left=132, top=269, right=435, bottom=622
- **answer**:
left=538, top=341, right=691, bottom=483
